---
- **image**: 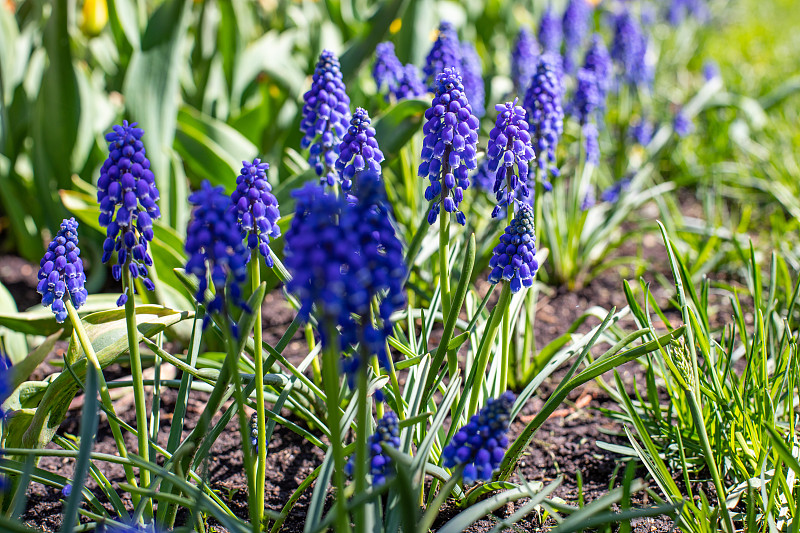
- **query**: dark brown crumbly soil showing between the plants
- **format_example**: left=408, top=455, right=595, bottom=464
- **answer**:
left=0, top=228, right=736, bottom=532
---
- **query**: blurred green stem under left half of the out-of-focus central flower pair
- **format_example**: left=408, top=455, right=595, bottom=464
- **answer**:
left=322, top=324, right=350, bottom=533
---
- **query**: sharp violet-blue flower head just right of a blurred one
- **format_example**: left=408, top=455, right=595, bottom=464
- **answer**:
left=231, top=158, right=281, bottom=268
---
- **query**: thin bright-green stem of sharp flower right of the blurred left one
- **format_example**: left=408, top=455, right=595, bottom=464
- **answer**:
left=249, top=249, right=267, bottom=531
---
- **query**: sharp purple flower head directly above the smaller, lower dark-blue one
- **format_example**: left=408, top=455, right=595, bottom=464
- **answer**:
left=486, top=99, right=536, bottom=218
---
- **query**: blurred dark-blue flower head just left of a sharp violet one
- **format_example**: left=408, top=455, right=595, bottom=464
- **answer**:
left=185, top=181, right=249, bottom=328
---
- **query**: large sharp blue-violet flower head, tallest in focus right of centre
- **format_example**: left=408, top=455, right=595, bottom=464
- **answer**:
left=418, top=68, right=480, bottom=226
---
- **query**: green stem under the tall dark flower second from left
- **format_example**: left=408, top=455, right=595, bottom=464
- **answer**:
left=122, top=268, right=153, bottom=517
